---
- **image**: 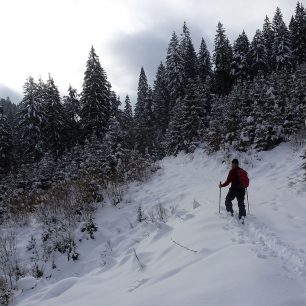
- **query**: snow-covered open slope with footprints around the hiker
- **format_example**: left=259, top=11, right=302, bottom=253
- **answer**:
left=13, top=145, right=306, bottom=306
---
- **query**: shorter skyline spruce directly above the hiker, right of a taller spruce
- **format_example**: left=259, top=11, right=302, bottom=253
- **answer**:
left=231, top=31, right=250, bottom=79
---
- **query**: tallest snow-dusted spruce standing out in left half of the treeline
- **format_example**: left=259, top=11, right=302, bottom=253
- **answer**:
left=80, top=47, right=111, bottom=140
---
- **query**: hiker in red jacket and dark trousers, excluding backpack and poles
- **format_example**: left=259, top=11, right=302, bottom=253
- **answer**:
left=219, top=158, right=246, bottom=219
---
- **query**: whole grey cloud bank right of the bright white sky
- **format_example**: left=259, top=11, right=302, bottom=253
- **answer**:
left=101, top=0, right=296, bottom=105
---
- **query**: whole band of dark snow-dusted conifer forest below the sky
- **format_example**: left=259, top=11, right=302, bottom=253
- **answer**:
left=0, top=3, right=306, bottom=216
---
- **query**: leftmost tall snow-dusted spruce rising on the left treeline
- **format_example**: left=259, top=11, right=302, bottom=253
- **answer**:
left=18, top=77, right=46, bottom=162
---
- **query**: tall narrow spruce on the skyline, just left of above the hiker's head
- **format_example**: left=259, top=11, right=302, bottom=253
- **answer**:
left=213, top=22, right=233, bottom=95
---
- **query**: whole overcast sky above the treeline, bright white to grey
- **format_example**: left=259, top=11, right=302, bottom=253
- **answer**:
left=0, top=0, right=303, bottom=102
